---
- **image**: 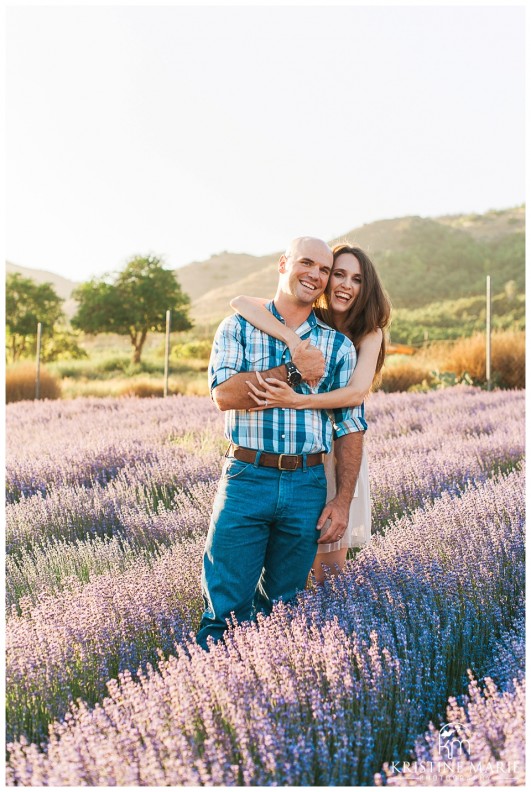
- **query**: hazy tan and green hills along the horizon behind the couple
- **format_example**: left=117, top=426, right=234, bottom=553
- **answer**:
left=7, top=206, right=525, bottom=325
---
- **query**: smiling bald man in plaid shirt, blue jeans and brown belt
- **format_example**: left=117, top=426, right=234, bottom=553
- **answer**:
left=197, top=237, right=367, bottom=649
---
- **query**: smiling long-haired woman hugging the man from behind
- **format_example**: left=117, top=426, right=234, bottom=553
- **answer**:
left=231, top=244, right=391, bottom=583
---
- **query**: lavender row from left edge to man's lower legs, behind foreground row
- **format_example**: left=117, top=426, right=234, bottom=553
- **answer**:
left=6, top=542, right=203, bottom=739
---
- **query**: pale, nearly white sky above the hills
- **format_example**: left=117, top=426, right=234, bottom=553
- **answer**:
left=6, top=6, right=525, bottom=280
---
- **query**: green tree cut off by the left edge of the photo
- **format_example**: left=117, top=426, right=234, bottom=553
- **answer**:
left=6, top=272, right=63, bottom=362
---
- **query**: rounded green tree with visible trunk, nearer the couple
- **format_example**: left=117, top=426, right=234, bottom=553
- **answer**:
left=72, top=256, right=192, bottom=363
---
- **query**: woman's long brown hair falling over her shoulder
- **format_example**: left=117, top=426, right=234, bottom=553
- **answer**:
left=314, top=243, right=391, bottom=384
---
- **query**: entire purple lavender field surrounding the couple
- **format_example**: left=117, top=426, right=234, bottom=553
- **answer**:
left=6, top=387, right=525, bottom=786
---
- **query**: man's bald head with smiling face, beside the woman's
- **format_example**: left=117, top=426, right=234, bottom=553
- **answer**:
left=278, top=237, right=333, bottom=305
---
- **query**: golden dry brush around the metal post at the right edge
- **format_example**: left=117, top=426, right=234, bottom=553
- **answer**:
left=440, top=331, right=525, bottom=388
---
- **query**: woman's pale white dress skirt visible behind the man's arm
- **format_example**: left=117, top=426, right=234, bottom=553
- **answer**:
left=317, top=444, right=371, bottom=555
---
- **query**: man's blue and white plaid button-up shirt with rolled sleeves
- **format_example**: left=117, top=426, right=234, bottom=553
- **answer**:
left=209, top=302, right=367, bottom=454
